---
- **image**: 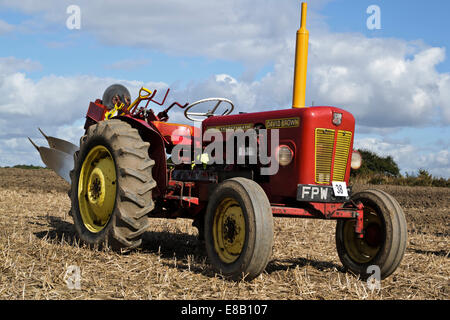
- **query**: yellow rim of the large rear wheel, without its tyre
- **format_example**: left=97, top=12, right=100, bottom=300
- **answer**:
left=78, top=145, right=117, bottom=233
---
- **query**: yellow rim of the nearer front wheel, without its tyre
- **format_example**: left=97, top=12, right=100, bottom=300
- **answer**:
left=213, top=198, right=246, bottom=263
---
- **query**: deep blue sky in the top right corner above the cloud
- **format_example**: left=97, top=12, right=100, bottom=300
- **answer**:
left=322, top=0, right=450, bottom=72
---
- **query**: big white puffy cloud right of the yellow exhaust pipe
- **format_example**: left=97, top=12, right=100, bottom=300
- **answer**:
left=310, top=34, right=450, bottom=127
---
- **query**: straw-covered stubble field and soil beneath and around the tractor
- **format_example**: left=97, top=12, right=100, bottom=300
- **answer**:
left=0, top=168, right=450, bottom=300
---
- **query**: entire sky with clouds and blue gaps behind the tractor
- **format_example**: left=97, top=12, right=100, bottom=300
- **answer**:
left=0, top=0, right=450, bottom=178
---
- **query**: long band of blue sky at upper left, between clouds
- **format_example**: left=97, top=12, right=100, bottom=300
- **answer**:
left=0, top=7, right=248, bottom=83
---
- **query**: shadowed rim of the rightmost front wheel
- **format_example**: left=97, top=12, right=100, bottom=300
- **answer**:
left=343, top=207, right=383, bottom=263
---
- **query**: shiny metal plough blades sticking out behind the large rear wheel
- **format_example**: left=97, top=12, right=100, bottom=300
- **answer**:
left=28, top=129, right=79, bottom=183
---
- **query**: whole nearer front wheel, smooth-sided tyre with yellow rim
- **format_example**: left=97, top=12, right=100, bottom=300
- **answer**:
left=204, top=178, right=273, bottom=281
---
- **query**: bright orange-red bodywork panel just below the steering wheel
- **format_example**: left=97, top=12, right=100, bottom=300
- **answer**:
left=153, top=121, right=200, bottom=145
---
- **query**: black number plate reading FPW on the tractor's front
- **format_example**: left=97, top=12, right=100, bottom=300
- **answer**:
left=297, top=182, right=351, bottom=202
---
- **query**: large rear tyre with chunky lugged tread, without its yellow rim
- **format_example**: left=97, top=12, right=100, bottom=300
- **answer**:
left=70, top=119, right=156, bottom=250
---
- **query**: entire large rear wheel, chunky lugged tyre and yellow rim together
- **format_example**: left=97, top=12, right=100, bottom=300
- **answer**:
left=70, top=119, right=156, bottom=250
